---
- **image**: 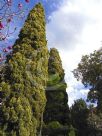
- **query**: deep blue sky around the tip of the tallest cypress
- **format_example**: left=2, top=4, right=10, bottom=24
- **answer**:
left=0, top=0, right=63, bottom=47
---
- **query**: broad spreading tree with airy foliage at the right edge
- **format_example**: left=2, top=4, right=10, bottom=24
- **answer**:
left=73, top=48, right=102, bottom=111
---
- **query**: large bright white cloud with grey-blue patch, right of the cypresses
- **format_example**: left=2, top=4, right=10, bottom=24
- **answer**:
left=47, top=0, right=102, bottom=105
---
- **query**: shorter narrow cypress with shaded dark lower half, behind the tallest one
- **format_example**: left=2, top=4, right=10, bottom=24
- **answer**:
left=44, top=48, right=70, bottom=136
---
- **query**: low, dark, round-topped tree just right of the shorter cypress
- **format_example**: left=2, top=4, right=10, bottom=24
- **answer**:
left=70, top=99, right=88, bottom=136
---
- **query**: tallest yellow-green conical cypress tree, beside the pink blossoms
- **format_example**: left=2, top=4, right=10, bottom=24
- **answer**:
left=0, top=3, right=48, bottom=136
